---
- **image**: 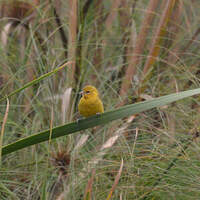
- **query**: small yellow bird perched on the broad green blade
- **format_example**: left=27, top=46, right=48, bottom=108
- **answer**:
left=78, top=85, right=104, bottom=117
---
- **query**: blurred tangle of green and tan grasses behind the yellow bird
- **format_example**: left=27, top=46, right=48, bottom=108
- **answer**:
left=0, top=0, right=200, bottom=200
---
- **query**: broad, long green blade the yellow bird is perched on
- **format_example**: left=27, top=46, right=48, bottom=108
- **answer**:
left=2, top=88, right=200, bottom=155
